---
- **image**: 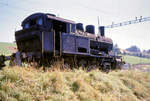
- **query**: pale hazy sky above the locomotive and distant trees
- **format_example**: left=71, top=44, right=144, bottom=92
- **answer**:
left=0, top=0, right=150, bottom=50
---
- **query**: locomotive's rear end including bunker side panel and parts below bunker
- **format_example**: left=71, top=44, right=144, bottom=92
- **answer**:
left=15, top=13, right=53, bottom=61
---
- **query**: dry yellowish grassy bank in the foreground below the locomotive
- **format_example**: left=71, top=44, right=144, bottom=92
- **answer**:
left=0, top=67, right=150, bottom=101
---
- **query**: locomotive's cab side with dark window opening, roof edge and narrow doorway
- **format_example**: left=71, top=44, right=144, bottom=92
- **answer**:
left=46, top=14, right=75, bottom=55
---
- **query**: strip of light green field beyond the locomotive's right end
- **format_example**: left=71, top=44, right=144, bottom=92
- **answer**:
left=123, top=55, right=150, bottom=64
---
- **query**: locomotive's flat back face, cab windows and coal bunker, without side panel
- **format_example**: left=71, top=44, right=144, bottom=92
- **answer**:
left=15, top=14, right=44, bottom=53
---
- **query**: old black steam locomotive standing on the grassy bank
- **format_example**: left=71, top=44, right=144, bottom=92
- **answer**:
left=0, top=13, right=122, bottom=70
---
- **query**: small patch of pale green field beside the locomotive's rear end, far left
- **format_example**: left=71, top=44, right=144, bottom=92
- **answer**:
left=0, top=42, right=16, bottom=55
